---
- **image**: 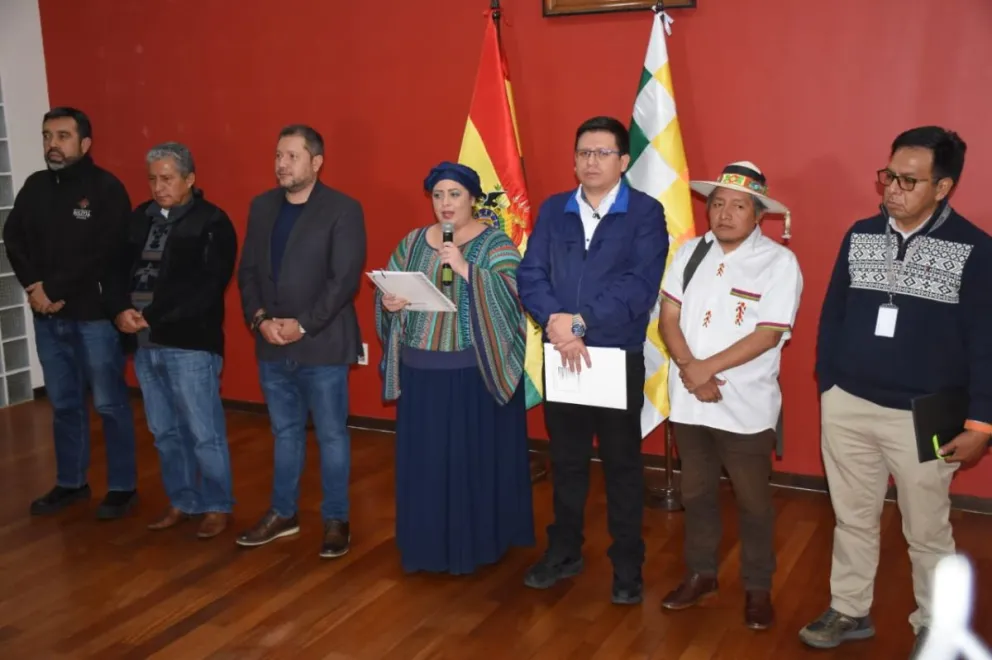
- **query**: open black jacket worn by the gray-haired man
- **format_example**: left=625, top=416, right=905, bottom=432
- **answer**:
left=103, top=188, right=238, bottom=356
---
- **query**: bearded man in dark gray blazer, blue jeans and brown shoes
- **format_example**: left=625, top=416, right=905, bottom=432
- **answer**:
left=237, top=125, right=365, bottom=558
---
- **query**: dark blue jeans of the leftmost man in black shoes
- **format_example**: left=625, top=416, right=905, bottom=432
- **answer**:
left=34, top=317, right=138, bottom=491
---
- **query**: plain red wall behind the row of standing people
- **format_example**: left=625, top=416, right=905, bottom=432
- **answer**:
left=39, top=0, right=992, bottom=497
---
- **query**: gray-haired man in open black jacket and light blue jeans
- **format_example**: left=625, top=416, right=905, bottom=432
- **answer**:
left=104, top=142, right=238, bottom=539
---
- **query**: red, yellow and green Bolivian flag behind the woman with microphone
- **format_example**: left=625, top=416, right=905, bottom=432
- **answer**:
left=458, top=12, right=543, bottom=408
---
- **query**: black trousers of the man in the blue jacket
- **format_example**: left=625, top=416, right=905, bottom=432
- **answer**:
left=544, top=351, right=644, bottom=581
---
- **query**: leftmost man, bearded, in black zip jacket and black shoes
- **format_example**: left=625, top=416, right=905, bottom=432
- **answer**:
left=3, top=108, right=137, bottom=519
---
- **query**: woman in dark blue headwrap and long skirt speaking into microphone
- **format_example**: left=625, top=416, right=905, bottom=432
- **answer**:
left=376, top=162, right=535, bottom=574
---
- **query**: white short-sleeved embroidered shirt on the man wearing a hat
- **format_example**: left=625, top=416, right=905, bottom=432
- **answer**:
left=662, top=228, right=803, bottom=434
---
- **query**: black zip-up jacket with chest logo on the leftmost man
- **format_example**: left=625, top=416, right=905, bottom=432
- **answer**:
left=3, top=155, right=131, bottom=321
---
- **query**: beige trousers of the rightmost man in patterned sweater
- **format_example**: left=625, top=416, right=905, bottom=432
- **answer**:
left=820, top=387, right=957, bottom=631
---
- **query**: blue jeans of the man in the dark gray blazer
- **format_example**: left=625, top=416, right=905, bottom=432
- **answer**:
left=258, top=360, right=351, bottom=522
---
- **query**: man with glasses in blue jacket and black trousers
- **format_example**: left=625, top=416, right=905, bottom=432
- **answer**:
left=517, top=117, right=668, bottom=604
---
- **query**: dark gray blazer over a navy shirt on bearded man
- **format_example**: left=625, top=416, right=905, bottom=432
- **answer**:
left=238, top=181, right=366, bottom=365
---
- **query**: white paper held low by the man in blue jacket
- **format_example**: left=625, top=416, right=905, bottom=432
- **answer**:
left=544, top=344, right=627, bottom=410
